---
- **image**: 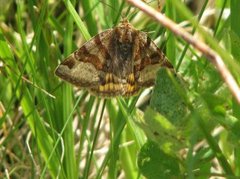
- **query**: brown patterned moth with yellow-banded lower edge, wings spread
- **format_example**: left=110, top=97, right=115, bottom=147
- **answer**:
left=55, top=20, right=173, bottom=97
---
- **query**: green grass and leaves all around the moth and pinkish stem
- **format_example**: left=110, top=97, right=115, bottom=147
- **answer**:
left=0, top=0, right=240, bottom=179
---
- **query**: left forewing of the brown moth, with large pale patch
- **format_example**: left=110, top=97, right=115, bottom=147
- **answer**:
left=55, top=29, right=112, bottom=88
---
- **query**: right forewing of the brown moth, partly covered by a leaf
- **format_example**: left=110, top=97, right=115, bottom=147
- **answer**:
left=137, top=32, right=173, bottom=87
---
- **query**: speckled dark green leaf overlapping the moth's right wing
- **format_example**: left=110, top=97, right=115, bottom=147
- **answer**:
left=150, top=68, right=188, bottom=125
